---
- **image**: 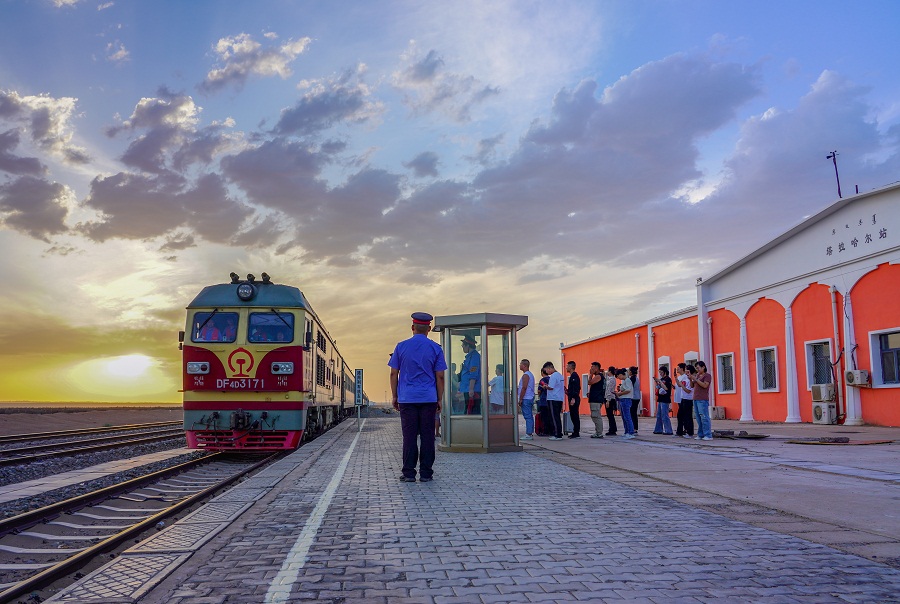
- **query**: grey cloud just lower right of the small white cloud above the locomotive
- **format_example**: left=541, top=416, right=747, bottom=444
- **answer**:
left=274, top=65, right=384, bottom=136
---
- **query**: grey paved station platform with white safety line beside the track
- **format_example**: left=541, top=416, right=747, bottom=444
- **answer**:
left=47, top=415, right=900, bottom=604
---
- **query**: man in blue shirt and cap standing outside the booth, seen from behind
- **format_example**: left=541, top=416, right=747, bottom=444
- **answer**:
left=388, top=312, right=447, bottom=482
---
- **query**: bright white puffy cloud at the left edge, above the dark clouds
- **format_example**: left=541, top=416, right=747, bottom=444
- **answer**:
left=0, top=90, right=90, bottom=165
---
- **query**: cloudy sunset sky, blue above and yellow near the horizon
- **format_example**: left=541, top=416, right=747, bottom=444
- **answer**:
left=0, top=0, right=900, bottom=402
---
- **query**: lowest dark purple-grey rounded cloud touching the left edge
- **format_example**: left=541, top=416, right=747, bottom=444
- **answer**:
left=0, top=176, right=72, bottom=243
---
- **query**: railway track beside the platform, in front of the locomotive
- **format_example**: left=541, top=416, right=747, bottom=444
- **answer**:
left=0, top=452, right=284, bottom=603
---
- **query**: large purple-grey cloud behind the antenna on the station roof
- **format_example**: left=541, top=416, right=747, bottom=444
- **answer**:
left=698, top=70, right=900, bottom=259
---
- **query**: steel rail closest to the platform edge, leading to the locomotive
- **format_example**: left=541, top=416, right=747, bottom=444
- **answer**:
left=0, top=451, right=284, bottom=603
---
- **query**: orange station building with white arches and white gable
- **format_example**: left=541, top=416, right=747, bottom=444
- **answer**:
left=562, top=184, right=900, bottom=426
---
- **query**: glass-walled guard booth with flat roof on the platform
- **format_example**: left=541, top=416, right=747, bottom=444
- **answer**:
left=434, top=313, right=528, bottom=453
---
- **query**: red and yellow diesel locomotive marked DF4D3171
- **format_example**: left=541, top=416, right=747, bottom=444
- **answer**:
left=179, top=273, right=365, bottom=451
